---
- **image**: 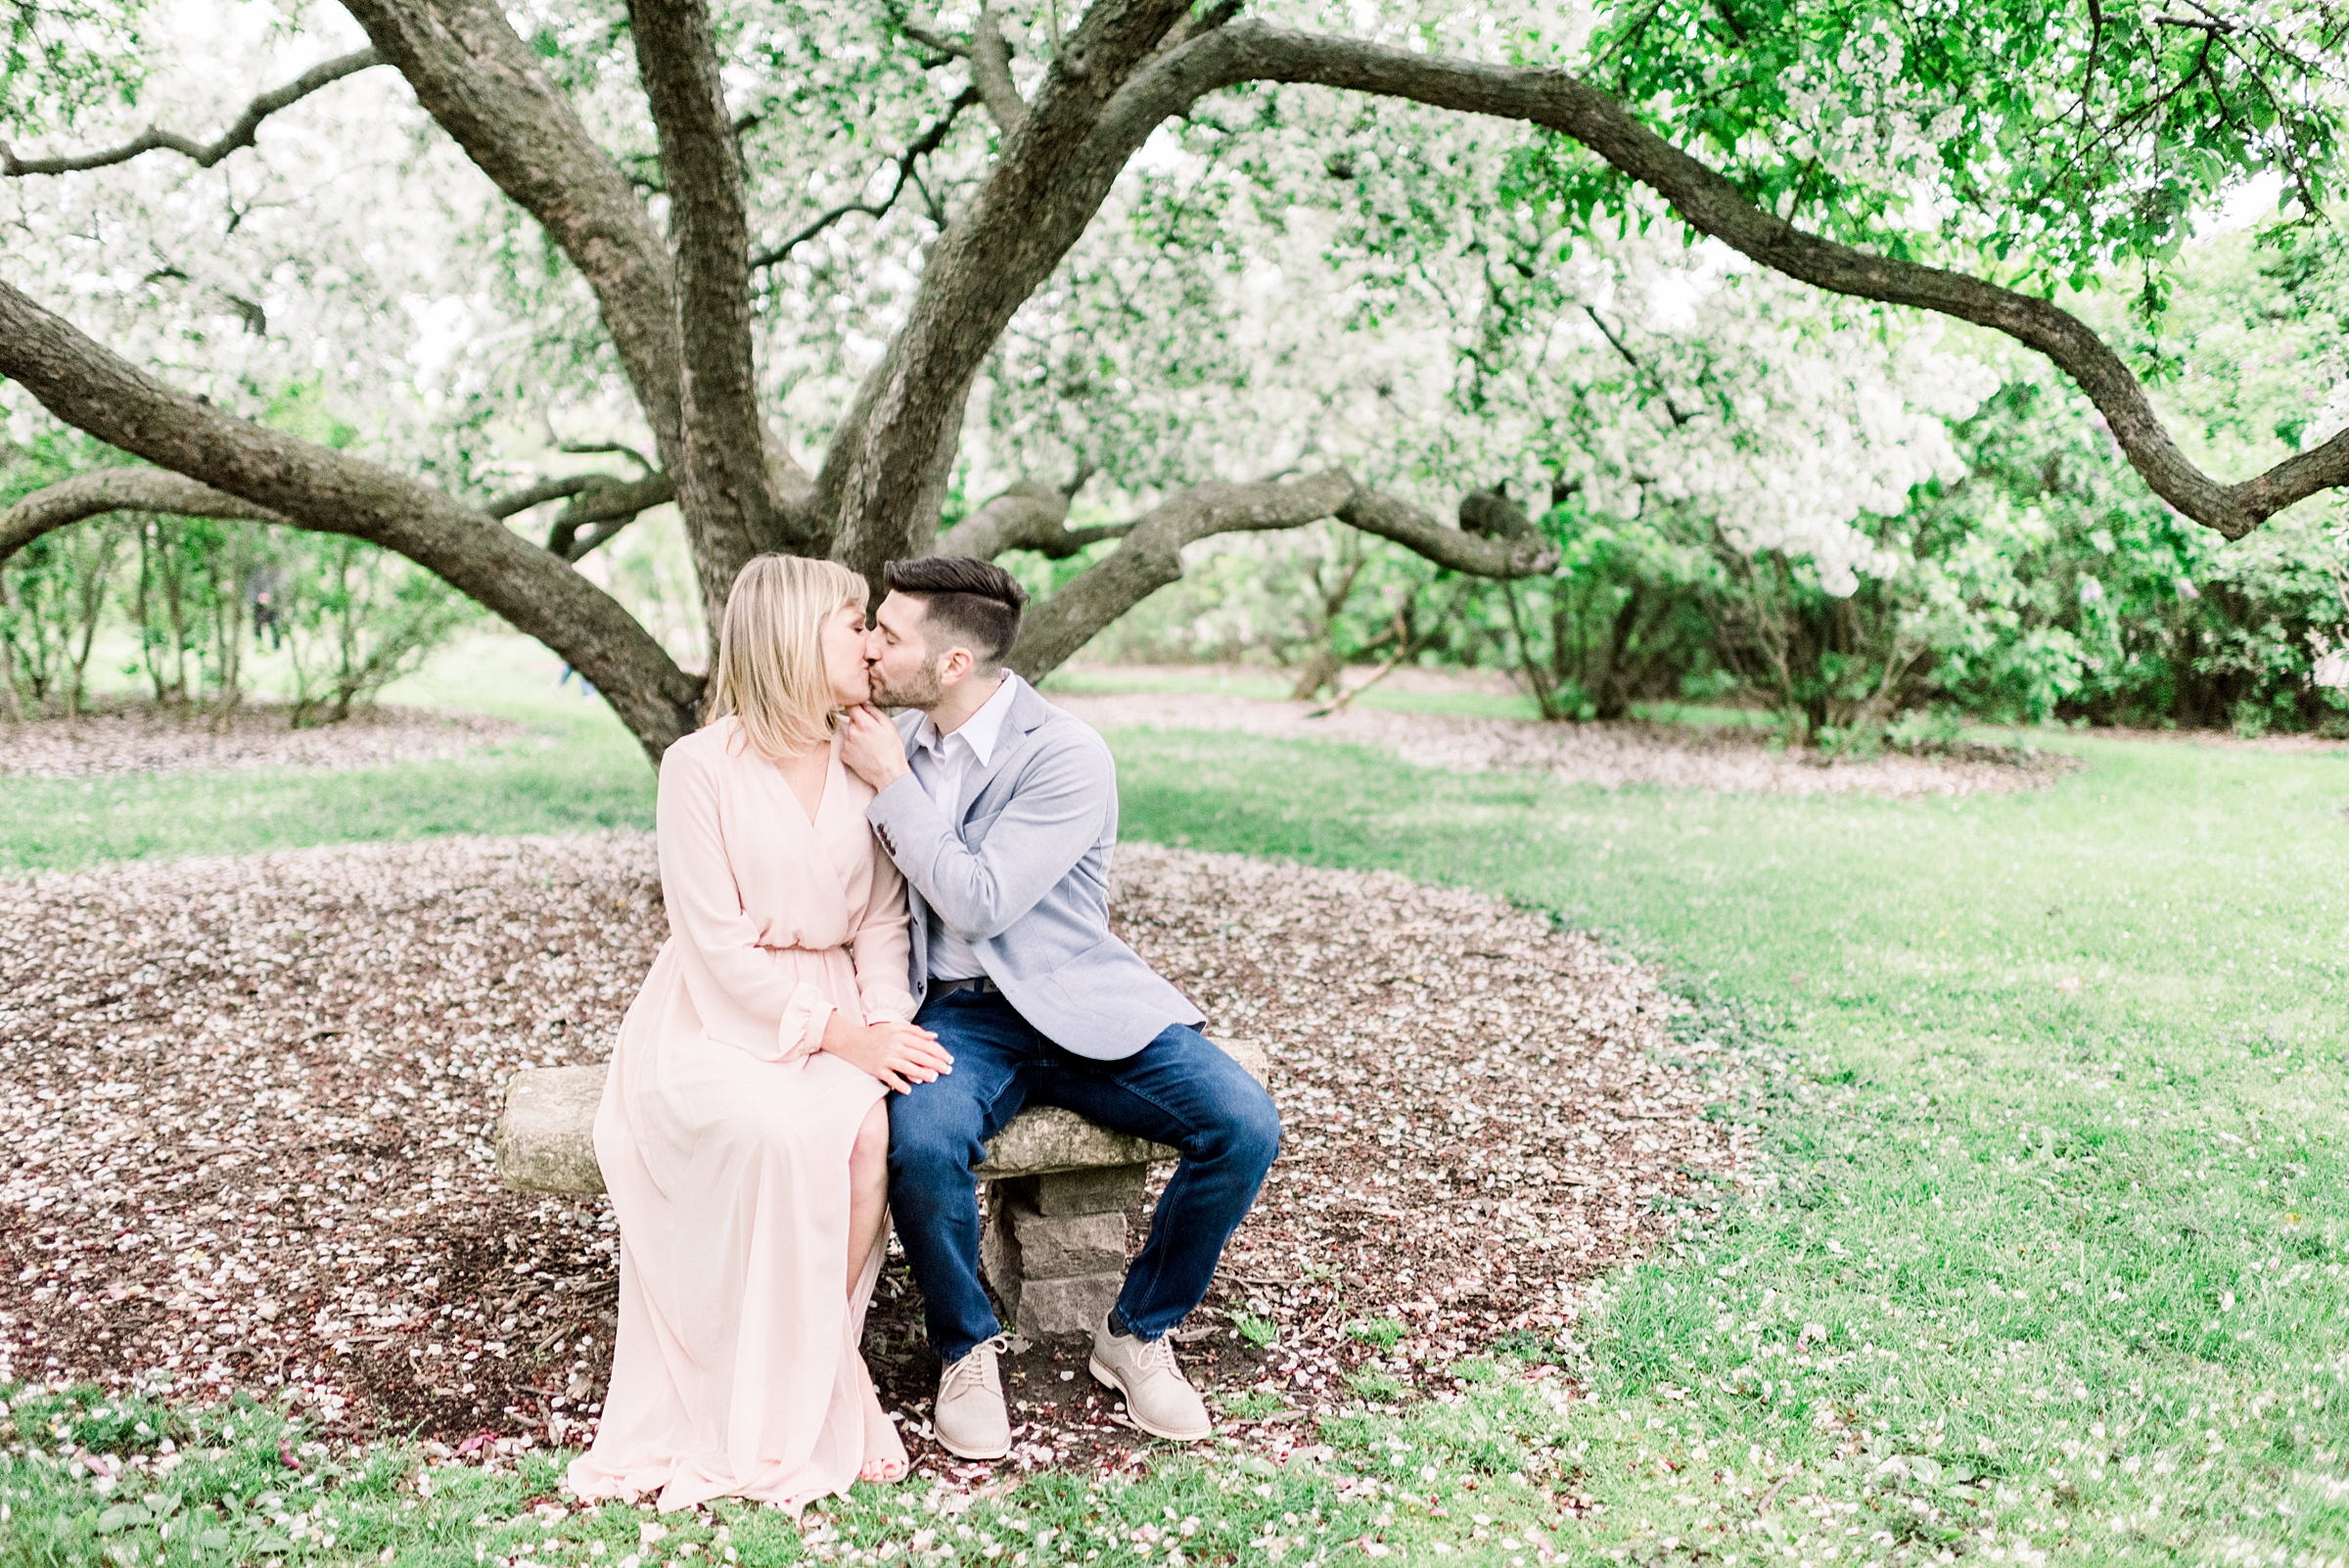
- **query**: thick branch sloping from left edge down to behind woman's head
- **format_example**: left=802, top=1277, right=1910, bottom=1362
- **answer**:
left=0, top=284, right=700, bottom=759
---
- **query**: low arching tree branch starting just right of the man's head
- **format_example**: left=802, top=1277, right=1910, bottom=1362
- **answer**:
left=1000, top=470, right=1557, bottom=680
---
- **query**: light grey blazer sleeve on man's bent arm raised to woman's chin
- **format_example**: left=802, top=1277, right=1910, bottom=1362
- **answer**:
left=867, top=723, right=1118, bottom=942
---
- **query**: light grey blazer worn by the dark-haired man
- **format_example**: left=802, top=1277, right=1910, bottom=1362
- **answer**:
left=867, top=673, right=1205, bottom=1061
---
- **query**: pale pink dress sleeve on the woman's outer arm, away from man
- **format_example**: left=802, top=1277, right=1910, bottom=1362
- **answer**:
left=653, top=747, right=836, bottom=1061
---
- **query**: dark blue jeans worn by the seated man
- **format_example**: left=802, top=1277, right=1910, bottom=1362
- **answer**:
left=888, top=991, right=1280, bottom=1366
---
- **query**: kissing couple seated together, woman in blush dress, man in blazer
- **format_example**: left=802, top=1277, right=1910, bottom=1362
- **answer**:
left=556, top=556, right=1280, bottom=1509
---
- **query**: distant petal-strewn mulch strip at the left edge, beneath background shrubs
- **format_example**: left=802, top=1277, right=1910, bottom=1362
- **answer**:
left=0, top=702, right=522, bottom=779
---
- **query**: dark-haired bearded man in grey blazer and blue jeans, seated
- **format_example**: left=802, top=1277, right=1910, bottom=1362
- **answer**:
left=841, top=559, right=1280, bottom=1460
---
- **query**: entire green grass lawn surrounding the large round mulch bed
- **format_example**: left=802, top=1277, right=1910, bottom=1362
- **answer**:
left=0, top=671, right=2349, bottom=1568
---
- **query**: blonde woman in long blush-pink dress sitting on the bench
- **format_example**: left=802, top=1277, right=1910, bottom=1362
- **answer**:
left=571, top=556, right=951, bottom=1509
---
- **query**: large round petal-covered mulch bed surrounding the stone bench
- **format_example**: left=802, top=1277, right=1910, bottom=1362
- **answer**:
left=0, top=836, right=1750, bottom=1479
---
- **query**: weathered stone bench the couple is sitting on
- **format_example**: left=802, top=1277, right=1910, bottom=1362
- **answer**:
left=498, top=1042, right=1268, bottom=1340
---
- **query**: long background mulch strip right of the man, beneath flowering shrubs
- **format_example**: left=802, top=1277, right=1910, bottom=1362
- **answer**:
left=1052, top=692, right=2084, bottom=801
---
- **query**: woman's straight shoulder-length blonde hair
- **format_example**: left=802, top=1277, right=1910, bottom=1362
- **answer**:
left=710, top=556, right=867, bottom=762
